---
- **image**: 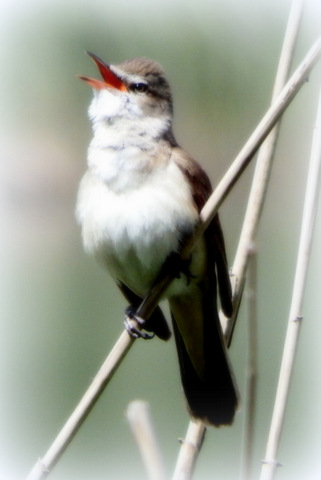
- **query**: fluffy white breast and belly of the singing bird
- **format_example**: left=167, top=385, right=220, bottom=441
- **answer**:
left=77, top=152, right=198, bottom=293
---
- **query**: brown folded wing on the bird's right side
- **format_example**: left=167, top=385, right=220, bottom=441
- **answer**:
left=173, top=147, right=233, bottom=317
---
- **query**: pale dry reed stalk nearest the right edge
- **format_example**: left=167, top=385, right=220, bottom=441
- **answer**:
left=260, top=91, right=321, bottom=480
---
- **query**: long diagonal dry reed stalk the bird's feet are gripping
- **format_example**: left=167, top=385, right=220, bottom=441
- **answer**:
left=27, top=38, right=321, bottom=480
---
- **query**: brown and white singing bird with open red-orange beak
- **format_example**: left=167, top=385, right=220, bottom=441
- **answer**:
left=76, top=52, right=238, bottom=427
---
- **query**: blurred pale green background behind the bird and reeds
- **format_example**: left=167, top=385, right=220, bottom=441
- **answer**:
left=0, top=0, right=321, bottom=480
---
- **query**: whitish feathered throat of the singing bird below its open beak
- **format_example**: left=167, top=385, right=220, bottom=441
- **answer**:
left=88, top=89, right=171, bottom=192
